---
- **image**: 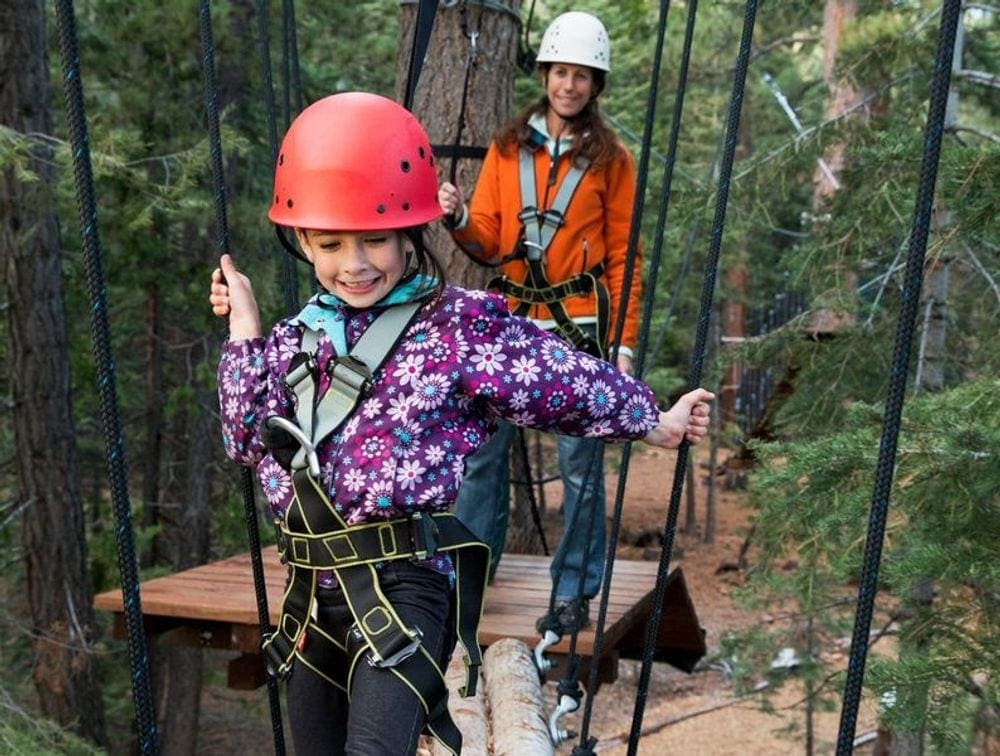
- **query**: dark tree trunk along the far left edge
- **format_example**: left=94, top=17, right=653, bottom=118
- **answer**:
left=0, top=0, right=107, bottom=745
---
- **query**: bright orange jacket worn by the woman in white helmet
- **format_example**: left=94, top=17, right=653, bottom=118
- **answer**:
left=452, top=131, right=642, bottom=349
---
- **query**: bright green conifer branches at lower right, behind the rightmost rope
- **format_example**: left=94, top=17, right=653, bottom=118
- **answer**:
left=746, top=379, right=1000, bottom=753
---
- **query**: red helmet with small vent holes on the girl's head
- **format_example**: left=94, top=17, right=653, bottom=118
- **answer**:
left=267, top=92, right=442, bottom=231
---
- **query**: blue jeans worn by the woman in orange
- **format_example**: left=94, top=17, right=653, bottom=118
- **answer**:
left=455, top=421, right=605, bottom=600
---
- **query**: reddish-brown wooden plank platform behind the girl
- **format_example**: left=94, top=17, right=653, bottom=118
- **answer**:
left=94, top=547, right=705, bottom=689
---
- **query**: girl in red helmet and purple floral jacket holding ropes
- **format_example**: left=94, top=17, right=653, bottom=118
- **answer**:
left=209, top=93, right=712, bottom=756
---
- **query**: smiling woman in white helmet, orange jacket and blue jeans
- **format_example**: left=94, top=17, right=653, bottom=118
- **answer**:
left=438, top=11, right=640, bottom=632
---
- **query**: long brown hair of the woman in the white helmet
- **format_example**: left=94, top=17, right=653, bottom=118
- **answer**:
left=493, top=63, right=625, bottom=170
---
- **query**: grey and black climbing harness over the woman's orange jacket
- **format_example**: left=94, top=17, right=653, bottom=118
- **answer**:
left=486, top=148, right=611, bottom=358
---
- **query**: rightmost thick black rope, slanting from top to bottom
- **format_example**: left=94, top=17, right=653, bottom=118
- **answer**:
left=837, top=0, right=962, bottom=756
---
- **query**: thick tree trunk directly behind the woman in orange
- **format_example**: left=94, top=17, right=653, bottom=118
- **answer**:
left=396, top=0, right=521, bottom=288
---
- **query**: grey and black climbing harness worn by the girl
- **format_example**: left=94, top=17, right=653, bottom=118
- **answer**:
left=263, top=302, right=489, bottom=754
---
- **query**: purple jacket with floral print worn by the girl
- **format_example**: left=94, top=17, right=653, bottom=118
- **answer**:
left=218, top=286, right=659, bottom=524
